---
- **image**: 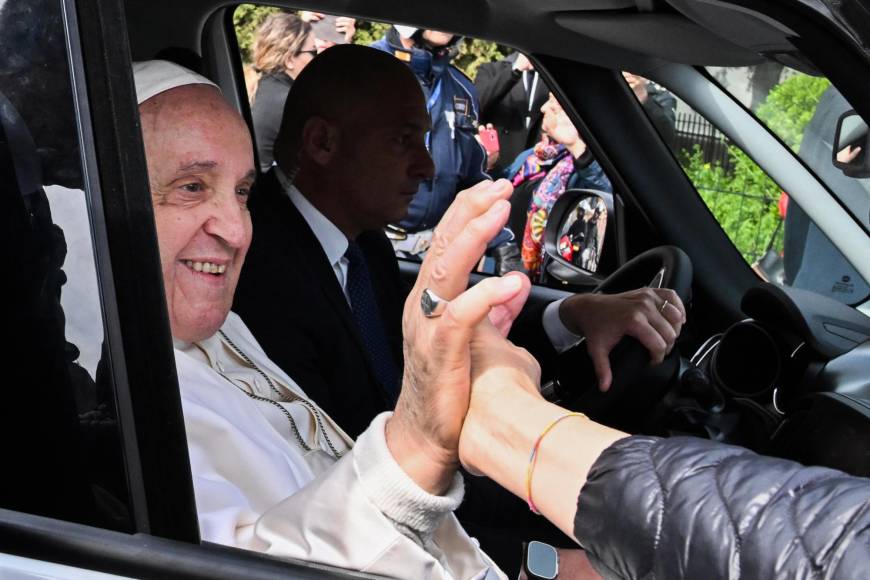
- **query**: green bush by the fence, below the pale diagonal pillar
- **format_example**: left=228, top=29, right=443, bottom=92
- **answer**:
left=680, top=145, right=782, bottom=264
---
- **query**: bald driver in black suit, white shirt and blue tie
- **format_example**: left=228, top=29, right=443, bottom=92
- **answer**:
left=233, top=45, right=682, bottom=570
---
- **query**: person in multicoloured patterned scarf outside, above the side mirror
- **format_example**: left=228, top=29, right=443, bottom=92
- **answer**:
left=505, top=93, right=613, bottom=280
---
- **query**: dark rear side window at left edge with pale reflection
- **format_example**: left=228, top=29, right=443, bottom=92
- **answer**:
left=0, top=2, right=130, bottom=530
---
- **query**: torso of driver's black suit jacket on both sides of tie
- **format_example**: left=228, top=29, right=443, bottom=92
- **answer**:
left=233, top=172, right=407, bottom=437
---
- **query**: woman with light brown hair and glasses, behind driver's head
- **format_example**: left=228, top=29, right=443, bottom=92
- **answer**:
left=251, top=12, right=317, bottom=171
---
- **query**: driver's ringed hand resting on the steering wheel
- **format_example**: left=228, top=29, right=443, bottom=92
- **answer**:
left=559, top=288, right=686, bottom=391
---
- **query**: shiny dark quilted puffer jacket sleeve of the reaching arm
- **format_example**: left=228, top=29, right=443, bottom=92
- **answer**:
left=574, top=436, right=870, bottom=580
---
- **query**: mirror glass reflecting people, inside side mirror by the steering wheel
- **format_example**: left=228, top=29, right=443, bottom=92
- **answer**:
left=558, top=196, right=607, bottom=273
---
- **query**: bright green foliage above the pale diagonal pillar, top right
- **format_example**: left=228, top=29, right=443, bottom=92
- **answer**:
left=756, top=74, right=831, bottom=151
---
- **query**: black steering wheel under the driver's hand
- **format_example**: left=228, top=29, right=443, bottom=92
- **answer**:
left=556, top=246, right=692, bottom=426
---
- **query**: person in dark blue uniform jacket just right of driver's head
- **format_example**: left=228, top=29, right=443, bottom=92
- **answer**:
left=371, top=26, right=521, bottom=273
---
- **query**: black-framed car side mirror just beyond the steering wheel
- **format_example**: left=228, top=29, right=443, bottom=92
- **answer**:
left=544, top=189, right=625, bottom=285
